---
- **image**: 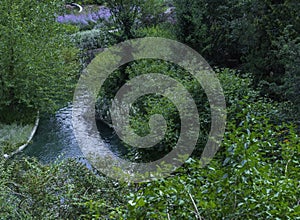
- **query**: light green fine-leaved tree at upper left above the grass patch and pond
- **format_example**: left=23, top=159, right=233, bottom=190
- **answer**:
left=0, top=0, right=78, bottom=120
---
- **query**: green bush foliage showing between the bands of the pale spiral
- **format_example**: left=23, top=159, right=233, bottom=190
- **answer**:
left=96, top=59, right=210, bottom=161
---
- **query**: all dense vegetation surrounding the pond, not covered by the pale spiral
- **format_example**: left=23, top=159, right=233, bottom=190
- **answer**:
left=0, top=0, right=300, bottom=219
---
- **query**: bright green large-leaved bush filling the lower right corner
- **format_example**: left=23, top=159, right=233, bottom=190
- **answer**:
left=118, top=102, right=300, bottom=219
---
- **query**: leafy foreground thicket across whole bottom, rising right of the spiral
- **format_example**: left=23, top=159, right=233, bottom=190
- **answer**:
left=0, top=68, right=300, bottom=219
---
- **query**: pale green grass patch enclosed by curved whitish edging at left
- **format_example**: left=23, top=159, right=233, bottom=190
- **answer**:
left=0, top=123, right=34, bottom=155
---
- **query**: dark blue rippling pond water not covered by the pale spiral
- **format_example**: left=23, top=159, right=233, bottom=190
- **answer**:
left=22, top=105, right=125, bottom=167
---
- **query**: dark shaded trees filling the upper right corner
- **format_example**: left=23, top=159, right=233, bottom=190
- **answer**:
left=174, top=0, right=300, bottom=107
